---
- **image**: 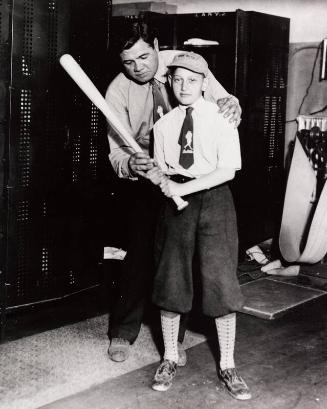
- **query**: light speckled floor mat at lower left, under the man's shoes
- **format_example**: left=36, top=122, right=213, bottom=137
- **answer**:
left=0, top=315, right=205, bottom=409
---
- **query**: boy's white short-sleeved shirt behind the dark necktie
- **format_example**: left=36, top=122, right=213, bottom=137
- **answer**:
left=154, top=97, right=241, bottom=196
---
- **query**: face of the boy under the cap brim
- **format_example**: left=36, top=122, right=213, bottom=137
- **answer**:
left=171, top=67, right=207, bottom=105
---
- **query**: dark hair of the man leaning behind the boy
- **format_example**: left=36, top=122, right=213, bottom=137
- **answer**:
left=109, top=14, right=157, bottom=54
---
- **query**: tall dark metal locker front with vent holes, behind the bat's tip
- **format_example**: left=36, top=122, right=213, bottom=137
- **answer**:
left=5, top=0, right=111, bottom=308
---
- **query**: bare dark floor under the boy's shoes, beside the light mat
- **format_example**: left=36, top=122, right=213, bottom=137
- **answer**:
left=42, top=297, right=327, bottom=409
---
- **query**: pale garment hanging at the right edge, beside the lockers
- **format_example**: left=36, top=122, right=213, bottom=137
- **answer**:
left=279, top=117, right=327, bottom=264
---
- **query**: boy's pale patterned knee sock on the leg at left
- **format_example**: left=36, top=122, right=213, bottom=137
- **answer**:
left=161, top=311, right=180, bottom=362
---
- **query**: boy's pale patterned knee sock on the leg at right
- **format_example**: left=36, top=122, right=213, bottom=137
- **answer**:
left=215, top=312, right=236, bottom=370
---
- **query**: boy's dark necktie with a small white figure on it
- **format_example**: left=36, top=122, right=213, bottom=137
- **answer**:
left=178, top=107, right=194, bottom=169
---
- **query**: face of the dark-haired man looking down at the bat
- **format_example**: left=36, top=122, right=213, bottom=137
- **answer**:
left=120, top=39, right=158, bottom=84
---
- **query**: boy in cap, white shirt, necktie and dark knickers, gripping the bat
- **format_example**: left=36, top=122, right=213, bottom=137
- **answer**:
left=148, top=52, right=251, bottom=400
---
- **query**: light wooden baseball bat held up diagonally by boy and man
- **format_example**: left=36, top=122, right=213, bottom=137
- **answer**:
left=59, top=54, right=188, bottom=210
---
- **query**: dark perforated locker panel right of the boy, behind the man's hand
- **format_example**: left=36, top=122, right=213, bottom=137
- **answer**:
left=234, top=12, right=289, bottom=247
